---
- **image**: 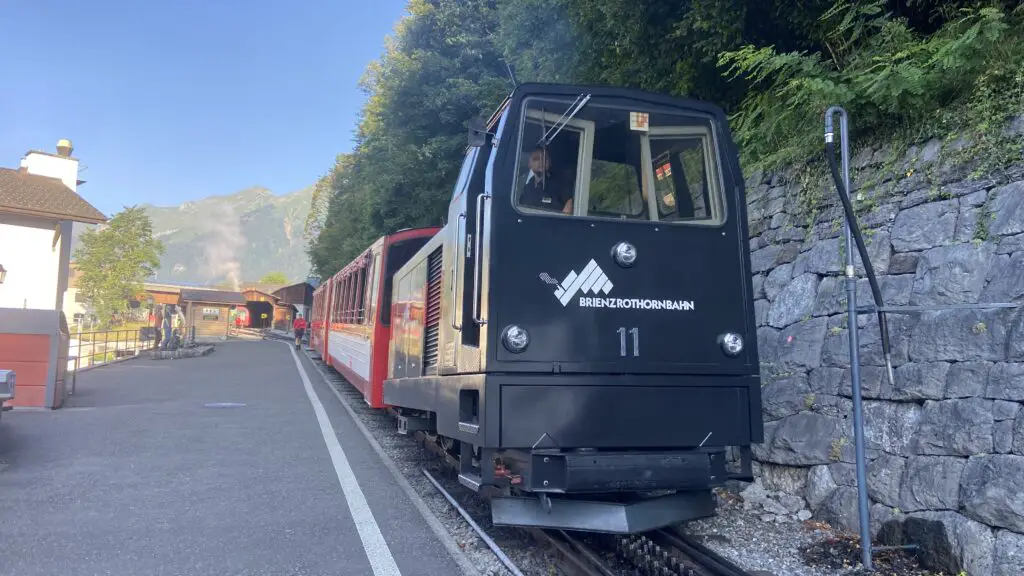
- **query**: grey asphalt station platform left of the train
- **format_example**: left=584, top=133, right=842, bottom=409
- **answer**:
left=0, top=340, right=471, bottom=576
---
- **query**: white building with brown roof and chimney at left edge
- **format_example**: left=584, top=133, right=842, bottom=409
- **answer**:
left=0, top=139, right=106, bottom=309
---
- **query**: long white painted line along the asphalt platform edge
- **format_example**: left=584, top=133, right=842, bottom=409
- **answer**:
left=285, top=342, right=401, bottom=576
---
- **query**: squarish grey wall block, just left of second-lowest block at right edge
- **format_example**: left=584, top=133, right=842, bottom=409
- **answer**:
left=898, top=456, right=967, bottom=512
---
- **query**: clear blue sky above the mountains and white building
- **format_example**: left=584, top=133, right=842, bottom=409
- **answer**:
left=0, top=0, right=406, bottom=214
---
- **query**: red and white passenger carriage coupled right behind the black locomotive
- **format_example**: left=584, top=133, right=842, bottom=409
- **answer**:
left=309, top=227, right=440, bottom=408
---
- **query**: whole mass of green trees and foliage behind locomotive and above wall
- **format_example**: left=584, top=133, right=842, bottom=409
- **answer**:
left=306, top=0, right=1024, bottom=276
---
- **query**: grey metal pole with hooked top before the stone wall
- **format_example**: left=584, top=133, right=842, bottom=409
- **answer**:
left=825, top=107, right=872, bottom=570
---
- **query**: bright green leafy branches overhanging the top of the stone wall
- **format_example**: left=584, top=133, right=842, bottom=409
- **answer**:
left=720, top=0, right=1024, bottom=168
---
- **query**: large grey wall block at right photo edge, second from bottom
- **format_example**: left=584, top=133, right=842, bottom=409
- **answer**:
left=959, top=454, right=1024, bottom=533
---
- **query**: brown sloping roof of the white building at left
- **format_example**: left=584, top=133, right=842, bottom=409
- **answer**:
left=0, top=168, right=106, bottom=224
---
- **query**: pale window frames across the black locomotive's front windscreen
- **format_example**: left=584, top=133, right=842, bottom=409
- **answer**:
left=507, top=95, right=730, bottom=229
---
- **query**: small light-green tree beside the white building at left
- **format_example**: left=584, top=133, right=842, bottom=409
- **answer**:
left=75, top=206, right=164, bottom=326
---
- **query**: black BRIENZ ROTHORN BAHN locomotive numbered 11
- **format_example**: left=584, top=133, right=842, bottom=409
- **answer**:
left=384, top=84, right=763, bottom=532
